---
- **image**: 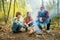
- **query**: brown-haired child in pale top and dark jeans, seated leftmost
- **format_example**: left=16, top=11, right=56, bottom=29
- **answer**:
left=12, top=12, right=22, bottom=33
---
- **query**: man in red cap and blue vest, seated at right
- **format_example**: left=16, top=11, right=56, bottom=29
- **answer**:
left=36, top=6, right=50, bottom=33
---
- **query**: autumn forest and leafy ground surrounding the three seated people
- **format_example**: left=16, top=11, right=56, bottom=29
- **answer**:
left=0, top=0, right=60, bottom=40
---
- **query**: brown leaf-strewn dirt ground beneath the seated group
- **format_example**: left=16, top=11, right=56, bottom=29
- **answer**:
left=0, top=25, right=60, bottom=40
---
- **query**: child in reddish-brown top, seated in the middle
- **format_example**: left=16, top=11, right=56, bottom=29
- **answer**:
left=23, top=12, right=33, bottom=31
